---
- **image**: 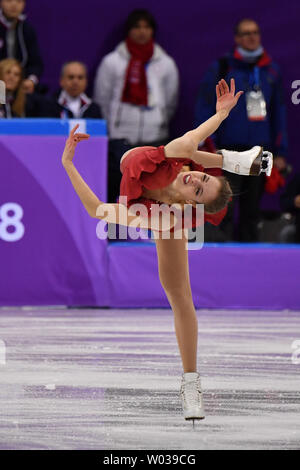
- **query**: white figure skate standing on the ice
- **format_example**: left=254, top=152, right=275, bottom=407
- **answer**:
left=180, top=372, right=205, bottom=425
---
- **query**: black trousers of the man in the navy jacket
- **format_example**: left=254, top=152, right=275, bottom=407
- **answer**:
left=220, top=172, right=265, bottom=242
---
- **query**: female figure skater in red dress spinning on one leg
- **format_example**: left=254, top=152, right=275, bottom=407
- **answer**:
left=62, top=79, right=272, bottom=420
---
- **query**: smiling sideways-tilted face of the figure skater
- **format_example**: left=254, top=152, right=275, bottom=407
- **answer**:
left=175, top=171, right=221, bottom=204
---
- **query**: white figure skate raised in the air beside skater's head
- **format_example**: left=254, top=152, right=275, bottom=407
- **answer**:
left=218, top=145, right=273, bottom=176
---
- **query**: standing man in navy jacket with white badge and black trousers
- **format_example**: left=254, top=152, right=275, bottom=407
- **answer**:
left=196, top=19, right=287, bottom=242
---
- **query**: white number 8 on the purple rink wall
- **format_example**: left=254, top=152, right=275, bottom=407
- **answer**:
left=0, top=202, right=25, bottom=242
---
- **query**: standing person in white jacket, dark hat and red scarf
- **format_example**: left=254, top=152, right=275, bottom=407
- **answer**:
left=94, top=10, right=178, bottom=202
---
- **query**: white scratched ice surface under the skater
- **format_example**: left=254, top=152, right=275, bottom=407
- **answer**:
left=0, top=308, right=300, bottom=450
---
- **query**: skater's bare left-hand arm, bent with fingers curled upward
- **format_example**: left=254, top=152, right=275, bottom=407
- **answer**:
left=62, top=124, right=176, bottom=231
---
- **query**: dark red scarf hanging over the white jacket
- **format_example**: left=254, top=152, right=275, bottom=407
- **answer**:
left=122, top=38, right=154, bottom=106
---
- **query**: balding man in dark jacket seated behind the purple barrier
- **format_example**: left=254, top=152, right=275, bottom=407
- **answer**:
left=44, top=61, right=102, bottom=119
